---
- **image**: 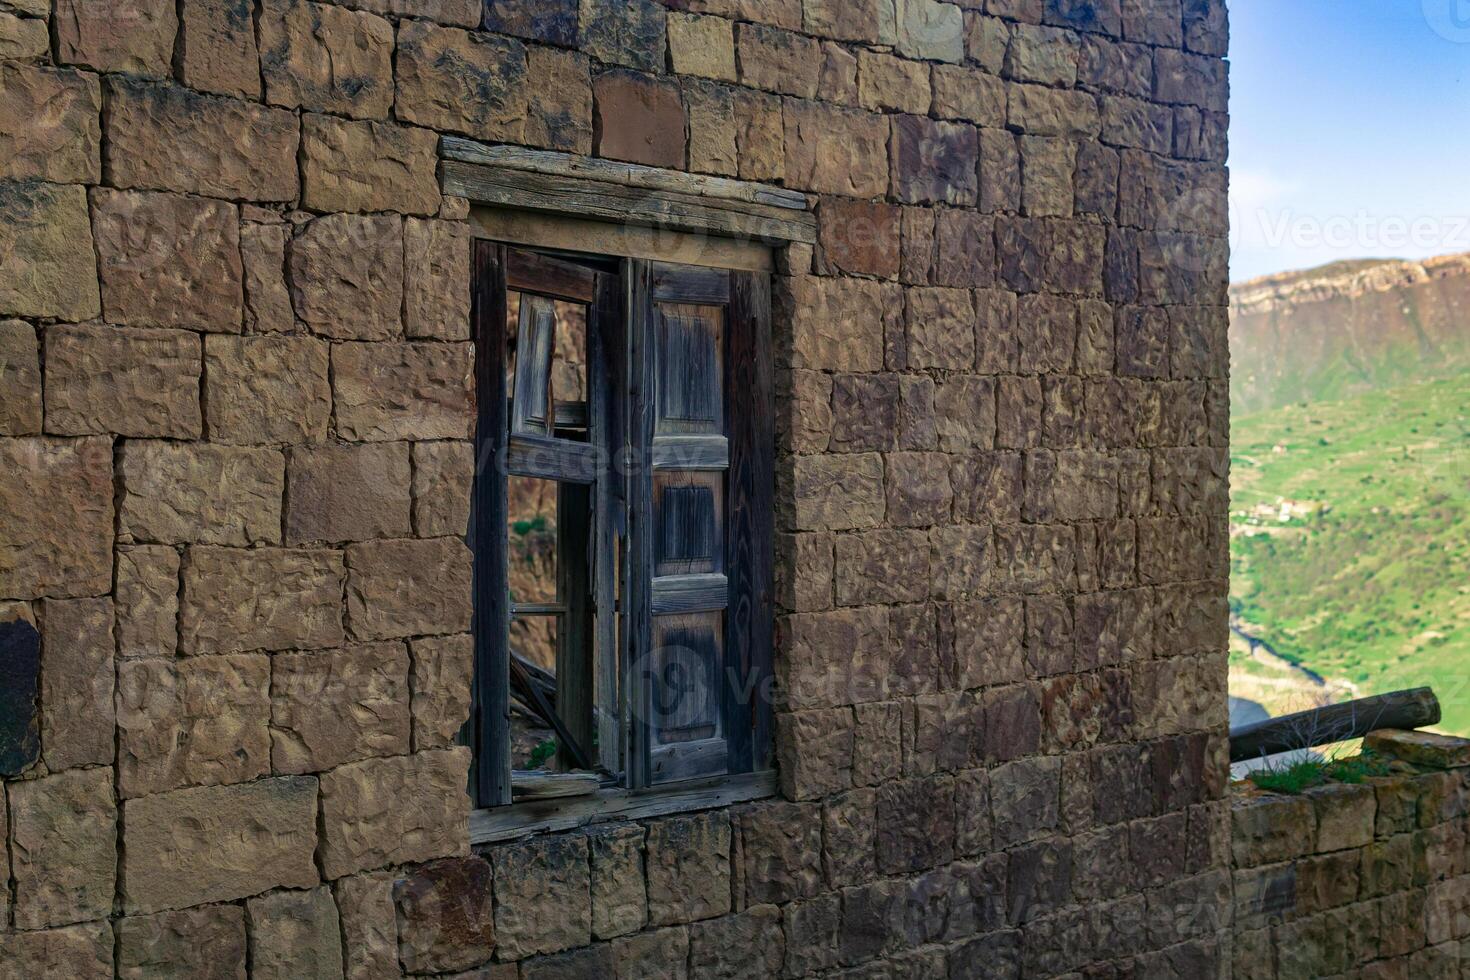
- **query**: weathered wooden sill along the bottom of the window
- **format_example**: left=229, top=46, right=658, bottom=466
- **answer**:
left=469, top=770, right=776, bottom=846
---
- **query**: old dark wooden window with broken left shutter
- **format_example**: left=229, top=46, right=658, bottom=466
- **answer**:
left=465, top=239, right=775, bottom=807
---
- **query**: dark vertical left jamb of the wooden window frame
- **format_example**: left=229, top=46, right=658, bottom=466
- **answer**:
left=470, top=241, right=510, bottom=807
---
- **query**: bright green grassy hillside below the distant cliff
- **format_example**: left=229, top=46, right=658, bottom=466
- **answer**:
left=1230, top=373, right=1470, bottom=735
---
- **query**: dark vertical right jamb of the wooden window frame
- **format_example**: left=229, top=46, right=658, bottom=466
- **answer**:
left=725, top=272, right=776, bottom=771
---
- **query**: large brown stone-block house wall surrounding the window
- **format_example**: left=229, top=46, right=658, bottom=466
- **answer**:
left=0, top=0, right=1230, bottom=980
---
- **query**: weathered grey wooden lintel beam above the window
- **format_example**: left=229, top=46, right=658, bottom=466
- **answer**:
left=440, top=160, right=816, bottom=245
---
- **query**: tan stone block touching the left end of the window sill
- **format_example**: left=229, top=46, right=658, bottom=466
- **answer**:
left=320, top=748, right=470, bottom=879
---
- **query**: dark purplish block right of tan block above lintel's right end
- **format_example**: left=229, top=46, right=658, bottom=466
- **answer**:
left=887, top=115, right=980, bottom=206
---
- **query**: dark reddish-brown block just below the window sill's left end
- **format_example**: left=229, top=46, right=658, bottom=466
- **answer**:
left=392, top=857, right=495, bottom=973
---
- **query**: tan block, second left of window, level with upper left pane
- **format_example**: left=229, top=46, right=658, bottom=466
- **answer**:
left=204, top=336, right=332, bottom=445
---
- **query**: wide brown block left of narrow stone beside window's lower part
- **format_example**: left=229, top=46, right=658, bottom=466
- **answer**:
left=270, top=644, right=409, bottom=773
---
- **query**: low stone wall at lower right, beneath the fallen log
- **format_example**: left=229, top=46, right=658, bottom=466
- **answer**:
left=1230, top=732, right=1470, bottom=980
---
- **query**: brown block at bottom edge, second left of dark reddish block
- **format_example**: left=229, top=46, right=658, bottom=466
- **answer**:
left=245, top=884, right=343, bottom=980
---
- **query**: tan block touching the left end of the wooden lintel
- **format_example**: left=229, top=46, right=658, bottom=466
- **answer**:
left=301, top=113, right=440, bottom=215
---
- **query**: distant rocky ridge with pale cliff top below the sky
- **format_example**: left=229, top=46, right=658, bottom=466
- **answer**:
left=1230, top=253, right=1470, bottom=413
